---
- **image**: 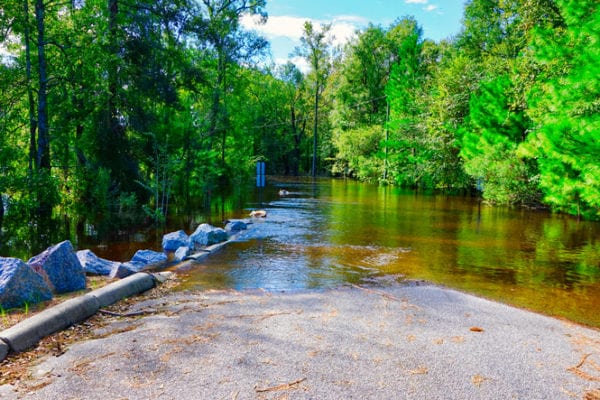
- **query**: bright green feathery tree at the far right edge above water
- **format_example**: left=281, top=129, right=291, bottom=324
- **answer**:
left=523, top=0, right=600, bottom=218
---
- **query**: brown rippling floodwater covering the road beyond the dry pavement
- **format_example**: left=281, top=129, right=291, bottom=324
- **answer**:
left=173, top=179, right=600, bottom=327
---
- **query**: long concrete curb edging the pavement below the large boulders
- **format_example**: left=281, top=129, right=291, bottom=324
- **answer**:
left=0, top=272, right=155, bottom=361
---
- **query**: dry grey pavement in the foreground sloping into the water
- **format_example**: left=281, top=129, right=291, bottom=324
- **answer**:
left=0, top=284, right=600, bottom=400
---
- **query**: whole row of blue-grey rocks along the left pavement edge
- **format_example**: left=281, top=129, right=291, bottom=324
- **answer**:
left=0, top=220, right=247, bottom=310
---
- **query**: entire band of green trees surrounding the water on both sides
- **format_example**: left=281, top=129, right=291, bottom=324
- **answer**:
left=0, top=0, right=600, bottom=258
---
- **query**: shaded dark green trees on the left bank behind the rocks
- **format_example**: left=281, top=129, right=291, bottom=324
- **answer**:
left=0, top=0, right=283, bottom=247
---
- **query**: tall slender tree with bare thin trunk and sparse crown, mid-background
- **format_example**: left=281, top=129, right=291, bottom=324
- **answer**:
left=296, top=21, right=331, bottom=177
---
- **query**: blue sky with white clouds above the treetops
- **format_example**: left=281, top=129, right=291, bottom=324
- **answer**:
left=243, top=0, right=465, bottom=67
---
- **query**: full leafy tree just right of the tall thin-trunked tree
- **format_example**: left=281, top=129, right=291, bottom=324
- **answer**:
left=330, top=25, right=396, bottom=180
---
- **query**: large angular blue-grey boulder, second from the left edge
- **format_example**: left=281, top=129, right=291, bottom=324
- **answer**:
left=27, top=240, right=86, bottom=293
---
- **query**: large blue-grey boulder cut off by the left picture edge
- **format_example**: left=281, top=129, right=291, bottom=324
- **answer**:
left=0, top=257, right=52, bottom=309
